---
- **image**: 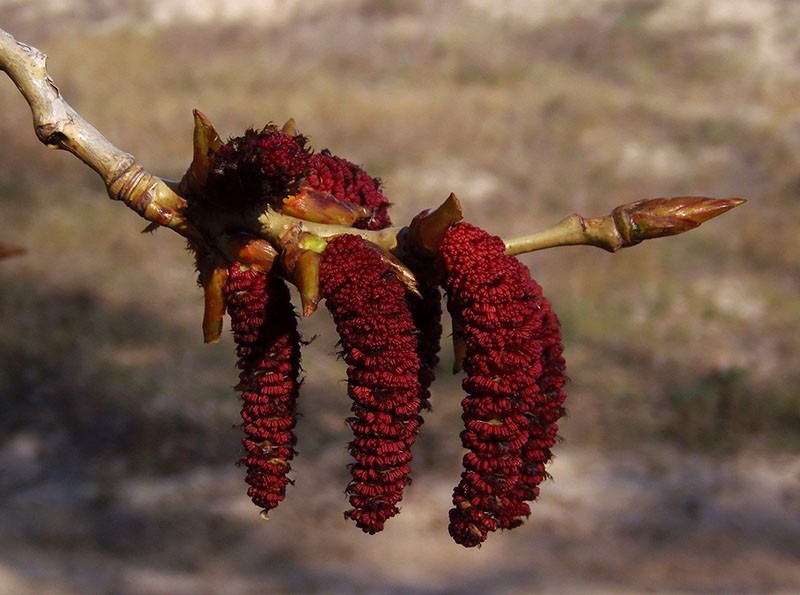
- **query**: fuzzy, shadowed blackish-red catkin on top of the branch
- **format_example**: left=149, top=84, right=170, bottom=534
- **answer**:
left=207, top=125, right=309, bottom=209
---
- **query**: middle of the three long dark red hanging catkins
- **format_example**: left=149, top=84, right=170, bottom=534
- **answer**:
left=320, top=235, right=422, bottom=534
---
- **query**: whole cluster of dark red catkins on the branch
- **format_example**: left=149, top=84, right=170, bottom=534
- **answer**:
left=189, top=126, right=566, bottom=547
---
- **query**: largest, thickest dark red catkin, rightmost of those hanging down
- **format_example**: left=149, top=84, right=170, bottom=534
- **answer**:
left=441, top=223, right=566, bottom=547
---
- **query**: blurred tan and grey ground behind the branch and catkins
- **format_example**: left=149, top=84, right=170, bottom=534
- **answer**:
left=0, top=0, right=800, bottom=595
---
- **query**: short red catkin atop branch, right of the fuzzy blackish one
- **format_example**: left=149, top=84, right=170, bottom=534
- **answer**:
left=306, top=150, right=392, bottom=229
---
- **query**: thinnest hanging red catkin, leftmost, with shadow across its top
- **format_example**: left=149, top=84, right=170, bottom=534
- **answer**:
left=224, top=263, right=300, bottom=515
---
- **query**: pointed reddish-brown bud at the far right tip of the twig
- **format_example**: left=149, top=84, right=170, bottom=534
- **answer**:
left=611, top=196, right=745, bottom=245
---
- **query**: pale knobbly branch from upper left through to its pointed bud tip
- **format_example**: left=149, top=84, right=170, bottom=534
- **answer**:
left=0, top=29, right=744, bottom=264
